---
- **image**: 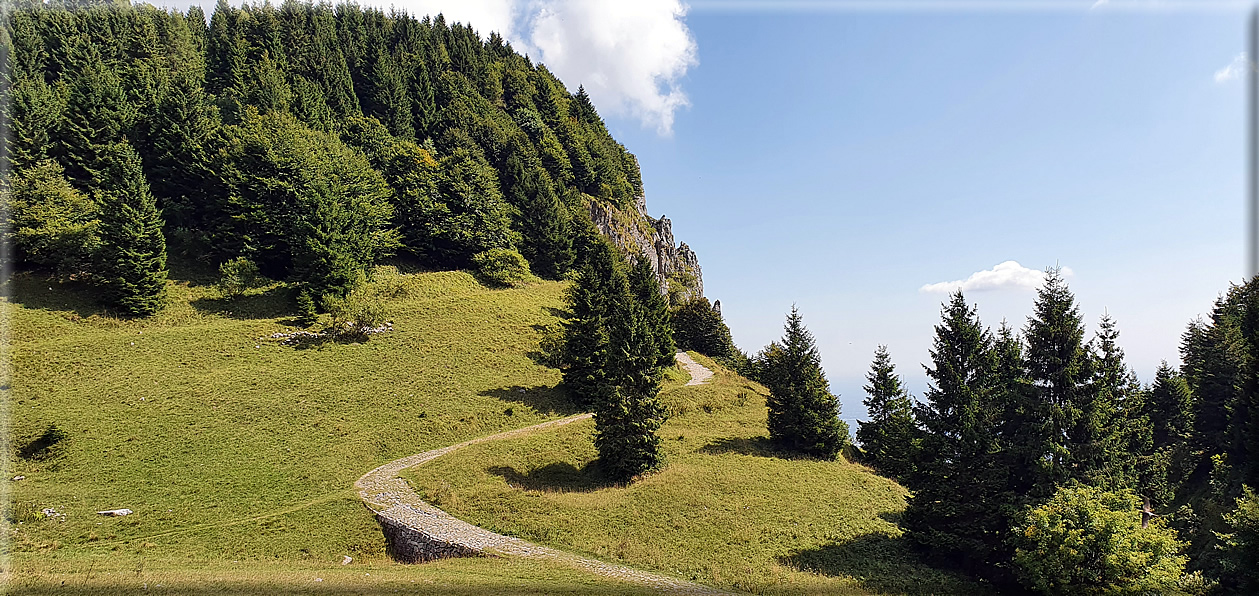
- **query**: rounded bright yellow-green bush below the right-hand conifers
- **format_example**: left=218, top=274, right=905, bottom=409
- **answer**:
left=1012, top=485, right=1186, bottom=595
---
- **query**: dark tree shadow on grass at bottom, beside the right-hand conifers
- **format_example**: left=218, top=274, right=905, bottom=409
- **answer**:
left=779, top=533, right=992, bottom=595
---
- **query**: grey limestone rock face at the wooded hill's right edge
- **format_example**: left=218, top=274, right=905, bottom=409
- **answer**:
left=588, top=197, right=704, bottom=304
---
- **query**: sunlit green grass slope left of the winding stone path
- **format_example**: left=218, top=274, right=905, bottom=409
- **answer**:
left=5, top=270, right=649, bottom=593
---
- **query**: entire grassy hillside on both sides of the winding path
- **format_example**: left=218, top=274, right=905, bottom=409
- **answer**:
left=4, top=267, right=968, bottom=593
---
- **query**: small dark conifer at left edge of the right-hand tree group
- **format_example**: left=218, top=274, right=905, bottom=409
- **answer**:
left=857, top=345, right=920, bottom=481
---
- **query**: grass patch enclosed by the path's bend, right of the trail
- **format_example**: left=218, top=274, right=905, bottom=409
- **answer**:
left=404, top=354, right=983, bottom=593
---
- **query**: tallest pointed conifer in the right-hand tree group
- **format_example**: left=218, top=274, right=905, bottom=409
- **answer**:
left=1024, top=268, right=1097, bottom=498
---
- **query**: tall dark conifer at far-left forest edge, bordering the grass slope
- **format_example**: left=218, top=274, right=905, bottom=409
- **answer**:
left=94, top=142, right=166, bottom=316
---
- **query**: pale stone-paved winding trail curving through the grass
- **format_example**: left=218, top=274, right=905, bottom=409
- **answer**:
left=354, top=352, right=734, bottom=595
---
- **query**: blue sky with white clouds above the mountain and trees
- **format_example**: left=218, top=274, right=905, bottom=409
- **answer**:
left=157, top=0, right=1246, bottom=417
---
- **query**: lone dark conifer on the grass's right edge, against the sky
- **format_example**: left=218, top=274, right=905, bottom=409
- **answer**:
left=765, top=306, right=847, bottom=459
